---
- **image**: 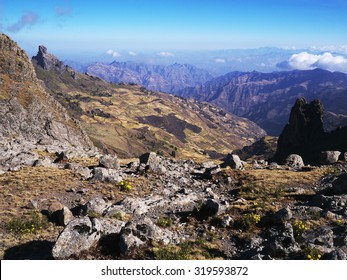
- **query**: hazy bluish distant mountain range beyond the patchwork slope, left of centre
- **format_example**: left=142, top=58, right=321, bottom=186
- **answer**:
left=87, top=61, right=213, bottom=93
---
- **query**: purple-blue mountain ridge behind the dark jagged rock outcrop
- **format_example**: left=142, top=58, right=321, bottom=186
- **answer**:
left=178, top=69, right=347, bottom=135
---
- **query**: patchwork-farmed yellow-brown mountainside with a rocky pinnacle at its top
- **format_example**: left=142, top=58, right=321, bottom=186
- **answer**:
left=33, top=47, right=265, bottom=158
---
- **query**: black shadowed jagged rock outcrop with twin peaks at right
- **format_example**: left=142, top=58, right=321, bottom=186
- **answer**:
left=273, top=98, right=347, bottom=165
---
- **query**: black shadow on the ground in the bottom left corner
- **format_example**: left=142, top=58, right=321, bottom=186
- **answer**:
left=4, top=241, right=54, bottom=260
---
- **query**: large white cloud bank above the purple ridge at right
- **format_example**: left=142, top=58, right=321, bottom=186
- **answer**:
left=277, top=52, right=347, bottom=72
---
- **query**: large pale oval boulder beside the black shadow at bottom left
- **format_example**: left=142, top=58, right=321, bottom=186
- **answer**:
left=52, top=217, right=102, bottom=259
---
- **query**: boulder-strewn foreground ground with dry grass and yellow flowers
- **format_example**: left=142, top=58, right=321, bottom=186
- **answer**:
left=0, top=151, right=347, bottom=259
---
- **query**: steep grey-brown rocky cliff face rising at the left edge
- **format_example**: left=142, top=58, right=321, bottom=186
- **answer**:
left=0, top=33, right=92, bottom=168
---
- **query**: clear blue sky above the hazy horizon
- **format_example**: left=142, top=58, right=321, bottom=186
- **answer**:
left=0, top=0, right=347, bottom=56
